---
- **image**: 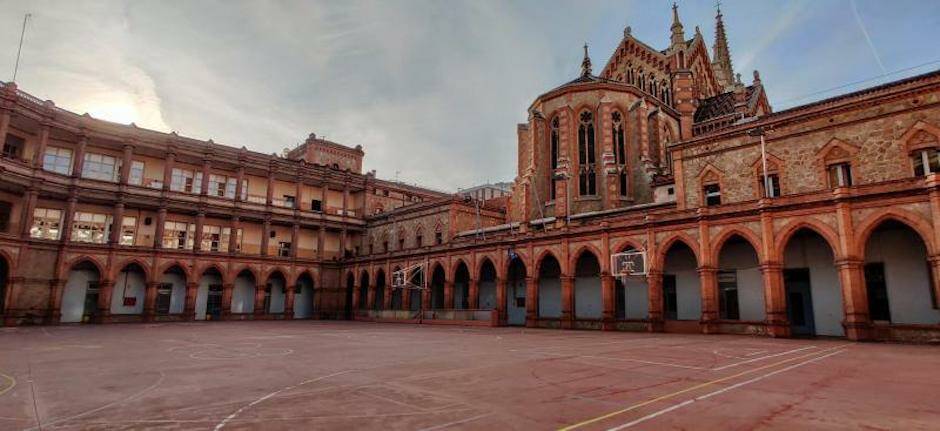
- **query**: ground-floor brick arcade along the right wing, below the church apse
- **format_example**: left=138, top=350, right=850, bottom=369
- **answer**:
left=346, top=211, right=940, bottom=341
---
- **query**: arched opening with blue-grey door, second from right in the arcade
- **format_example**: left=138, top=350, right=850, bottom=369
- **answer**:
left=783, top=228, right=845, bottom=336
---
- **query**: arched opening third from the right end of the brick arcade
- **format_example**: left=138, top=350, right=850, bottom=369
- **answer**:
left=717, top=234, right=765, bottom=322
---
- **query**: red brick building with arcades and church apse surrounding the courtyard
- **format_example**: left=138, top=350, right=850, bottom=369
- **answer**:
left=0, top=3, right=940, bottom=340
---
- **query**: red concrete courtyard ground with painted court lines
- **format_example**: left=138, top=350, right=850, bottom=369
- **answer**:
left=0, top=321, right=940, bottom=430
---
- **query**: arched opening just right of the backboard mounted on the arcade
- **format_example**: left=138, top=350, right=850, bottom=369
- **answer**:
left=663, top=241, right=702, bottom=321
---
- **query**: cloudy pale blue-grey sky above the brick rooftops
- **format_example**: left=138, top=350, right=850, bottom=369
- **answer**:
left=0, top=0, right=940, bottom=191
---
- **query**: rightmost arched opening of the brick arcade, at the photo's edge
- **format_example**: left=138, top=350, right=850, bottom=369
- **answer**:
left=864, top=219, right=940, bottom=325
